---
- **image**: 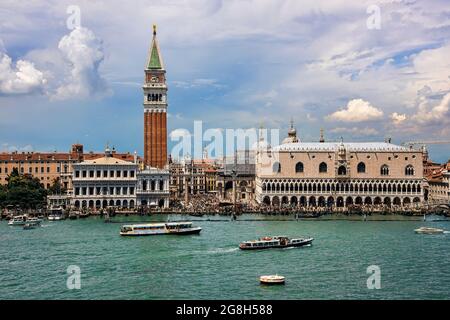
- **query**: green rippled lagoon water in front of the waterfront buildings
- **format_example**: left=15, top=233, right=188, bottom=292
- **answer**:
left=0, top=216, right=450, bottom=299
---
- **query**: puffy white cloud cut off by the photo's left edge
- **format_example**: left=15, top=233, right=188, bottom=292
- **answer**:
left=0, top=47, right=47, bottom=95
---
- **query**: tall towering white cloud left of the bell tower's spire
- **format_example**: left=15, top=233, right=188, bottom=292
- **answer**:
left=52, top=27, right=109, bottom=100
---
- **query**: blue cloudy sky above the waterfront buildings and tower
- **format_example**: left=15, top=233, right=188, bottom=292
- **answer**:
left=0, top=0, right=450, bottom=162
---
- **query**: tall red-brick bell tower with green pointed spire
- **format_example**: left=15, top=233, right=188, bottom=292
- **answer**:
left=142, top=25, right=167, bottom=169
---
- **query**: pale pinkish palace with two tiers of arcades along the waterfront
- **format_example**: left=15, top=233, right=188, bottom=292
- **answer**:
left=256, top=122, right=424, bottom=207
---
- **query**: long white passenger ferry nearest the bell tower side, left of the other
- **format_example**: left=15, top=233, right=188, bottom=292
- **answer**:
left=120, top=222, right=202, bottom=236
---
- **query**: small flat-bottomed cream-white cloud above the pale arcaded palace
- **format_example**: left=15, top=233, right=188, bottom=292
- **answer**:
left=326, top=99, right=383, bottom=122
